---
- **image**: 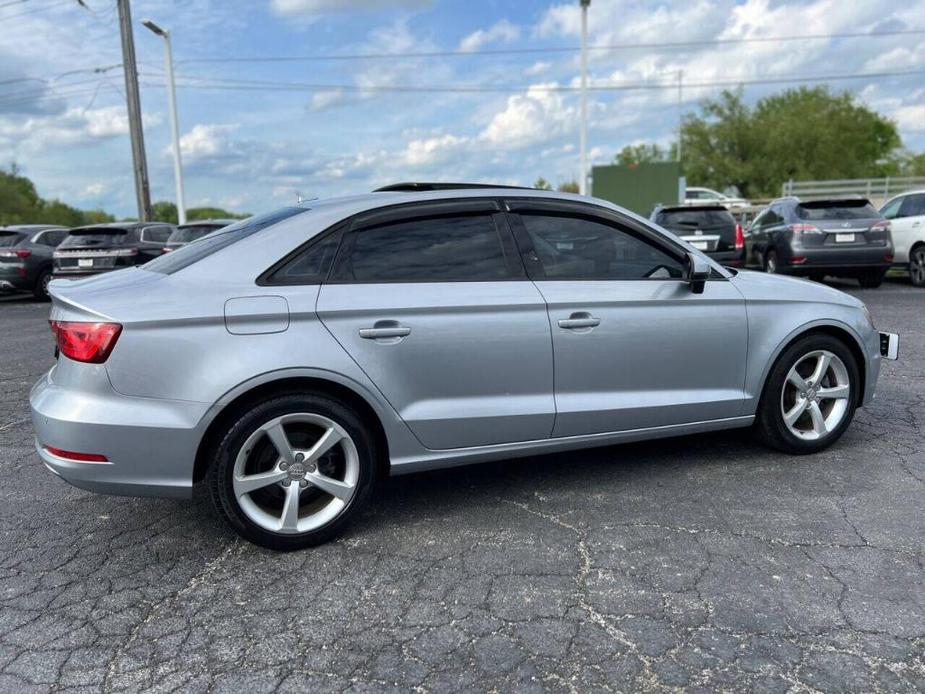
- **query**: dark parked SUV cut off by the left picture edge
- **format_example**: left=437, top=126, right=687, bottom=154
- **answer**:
left=0, top=224, right=67, bottom=300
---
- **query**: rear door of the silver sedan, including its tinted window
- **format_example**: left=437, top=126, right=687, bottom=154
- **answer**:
left=317, top=200, right=555, bottom=449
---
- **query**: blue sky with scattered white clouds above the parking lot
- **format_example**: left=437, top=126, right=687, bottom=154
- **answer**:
left=0, top=0, right=925, bottom=215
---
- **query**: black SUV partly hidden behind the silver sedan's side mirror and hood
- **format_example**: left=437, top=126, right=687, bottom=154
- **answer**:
left=651, top=203, right=745, bottom=267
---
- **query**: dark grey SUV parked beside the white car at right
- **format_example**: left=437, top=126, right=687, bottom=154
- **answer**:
left=745, top=197, right=893, bottom=287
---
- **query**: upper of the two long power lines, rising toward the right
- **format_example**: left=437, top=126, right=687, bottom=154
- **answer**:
left=177, top=29, right=925, bottom=64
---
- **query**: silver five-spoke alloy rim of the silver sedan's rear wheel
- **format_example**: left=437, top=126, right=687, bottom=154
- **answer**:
left=232, top=412, right=360, bottom=535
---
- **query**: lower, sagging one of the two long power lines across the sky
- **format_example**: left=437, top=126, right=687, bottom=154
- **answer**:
left=142, top=69, right=925, bottom=94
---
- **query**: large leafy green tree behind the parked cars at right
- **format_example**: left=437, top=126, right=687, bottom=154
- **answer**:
left=682, top=87, right=901, bottom=197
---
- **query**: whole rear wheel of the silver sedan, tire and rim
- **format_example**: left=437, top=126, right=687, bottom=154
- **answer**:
left=207, top=394, right=378, bottom=550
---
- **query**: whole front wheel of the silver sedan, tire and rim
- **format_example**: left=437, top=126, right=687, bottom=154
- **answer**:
left=755, top=334, right=860, bottom=454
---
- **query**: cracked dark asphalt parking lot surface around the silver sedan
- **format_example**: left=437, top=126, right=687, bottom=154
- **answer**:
left=0, top=282, right=925, bottom=693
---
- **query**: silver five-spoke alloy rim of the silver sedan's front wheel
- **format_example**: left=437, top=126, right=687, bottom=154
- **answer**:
left=780, top=350, right=851, bottom=441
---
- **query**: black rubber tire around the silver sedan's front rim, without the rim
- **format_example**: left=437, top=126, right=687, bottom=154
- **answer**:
left=754, top=333, right=861, bottom=455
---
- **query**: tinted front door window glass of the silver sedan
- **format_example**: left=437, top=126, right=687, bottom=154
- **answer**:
left=522, top=215, right=684, bottom=280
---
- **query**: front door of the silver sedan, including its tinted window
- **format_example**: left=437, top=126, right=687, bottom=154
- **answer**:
left=509, top=200, right=747, bottom=436
